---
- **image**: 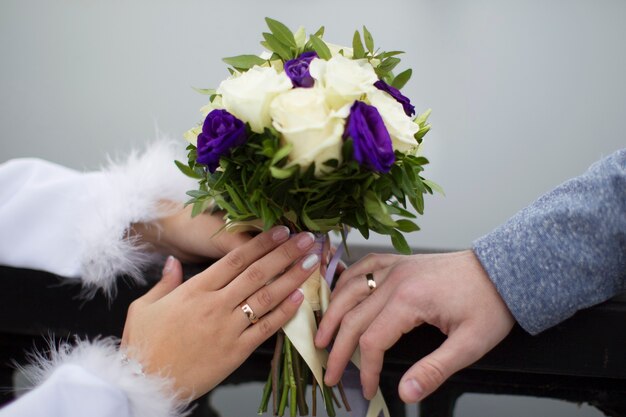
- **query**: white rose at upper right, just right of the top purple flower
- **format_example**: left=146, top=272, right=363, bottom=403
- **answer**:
left=309, top=55, right=378, bottom=109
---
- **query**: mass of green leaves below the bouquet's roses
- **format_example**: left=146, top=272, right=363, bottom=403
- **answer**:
left=177, top=120, right=438, bottom=253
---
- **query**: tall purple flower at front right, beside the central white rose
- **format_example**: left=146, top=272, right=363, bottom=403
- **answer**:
left=343, top=101, right=396, bottom=173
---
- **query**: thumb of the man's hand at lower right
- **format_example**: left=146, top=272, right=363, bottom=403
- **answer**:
left=398, top=333, right=486, bottom=403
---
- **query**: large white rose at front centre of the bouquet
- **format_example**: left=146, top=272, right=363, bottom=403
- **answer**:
left=270, top=87, right=349, bottom=175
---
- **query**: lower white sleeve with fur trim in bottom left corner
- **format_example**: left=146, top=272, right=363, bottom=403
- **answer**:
left=0, top=339, right=185, bottom=417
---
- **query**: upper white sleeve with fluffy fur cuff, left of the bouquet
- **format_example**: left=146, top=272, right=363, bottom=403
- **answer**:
left=0, top=142, right=194, bottom=294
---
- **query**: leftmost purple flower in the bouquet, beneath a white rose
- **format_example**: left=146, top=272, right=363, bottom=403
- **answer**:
left=197, top=110, right=246, bottom=173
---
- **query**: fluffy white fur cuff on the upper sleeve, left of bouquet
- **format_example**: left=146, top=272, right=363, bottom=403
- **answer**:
left=78, top=141, right=194, bottom=296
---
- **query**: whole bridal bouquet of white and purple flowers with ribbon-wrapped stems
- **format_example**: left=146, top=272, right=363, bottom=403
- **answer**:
left=176, top=18, right=438, bottom=416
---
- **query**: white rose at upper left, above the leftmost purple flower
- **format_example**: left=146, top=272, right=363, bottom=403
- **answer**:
left=217, top=66, right=292, bottom=133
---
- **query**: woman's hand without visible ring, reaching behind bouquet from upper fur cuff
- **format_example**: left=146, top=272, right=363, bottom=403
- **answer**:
left=131, top=202, right=251, bottom=262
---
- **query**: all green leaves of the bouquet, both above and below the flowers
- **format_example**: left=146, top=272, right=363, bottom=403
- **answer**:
left=176, top=18, right=441, bottom=253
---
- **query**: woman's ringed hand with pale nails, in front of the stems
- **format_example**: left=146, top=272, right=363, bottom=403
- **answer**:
left=122, top=226, right=319, bottom=399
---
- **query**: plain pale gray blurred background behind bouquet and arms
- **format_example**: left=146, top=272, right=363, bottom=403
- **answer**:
left=0, top=0, right=626, bottom=417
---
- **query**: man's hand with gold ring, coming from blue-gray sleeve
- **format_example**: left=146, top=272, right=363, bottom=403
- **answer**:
left=315, top=251, right=514, bottom=403
